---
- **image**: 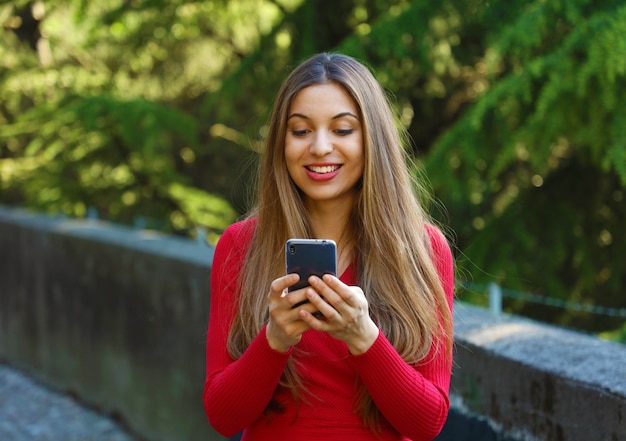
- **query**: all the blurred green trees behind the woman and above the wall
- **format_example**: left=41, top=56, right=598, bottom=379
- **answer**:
left=0, top=0, right=626, bottom=341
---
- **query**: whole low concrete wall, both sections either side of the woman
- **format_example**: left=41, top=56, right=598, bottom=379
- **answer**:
left=0, top=207, right=626, bottom=441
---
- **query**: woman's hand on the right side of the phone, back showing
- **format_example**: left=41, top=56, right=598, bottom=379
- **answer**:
left=299, top=274, right=379, bottom=355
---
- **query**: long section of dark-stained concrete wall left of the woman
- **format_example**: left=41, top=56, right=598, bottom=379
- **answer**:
left=0, top=208, right=219, bottom=441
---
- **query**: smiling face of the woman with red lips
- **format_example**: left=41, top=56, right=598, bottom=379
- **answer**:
left=285, top=83, right=364, bottom=207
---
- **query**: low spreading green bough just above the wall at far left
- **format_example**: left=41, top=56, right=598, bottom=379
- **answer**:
left=0, top=95, right=235, bottom=235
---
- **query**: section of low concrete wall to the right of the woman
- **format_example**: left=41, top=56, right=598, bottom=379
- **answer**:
left=451, top=304, right=626, bottom=441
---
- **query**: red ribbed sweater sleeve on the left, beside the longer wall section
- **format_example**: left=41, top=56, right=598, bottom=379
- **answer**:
left=203, top=221, right=290, bottom=436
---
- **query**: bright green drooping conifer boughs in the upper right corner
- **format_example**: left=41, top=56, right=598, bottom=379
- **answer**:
left=429, top=1, right=626, bottom=195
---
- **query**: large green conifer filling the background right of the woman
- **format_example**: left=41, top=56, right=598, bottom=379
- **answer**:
left=202, top=0, right=626, bottom=331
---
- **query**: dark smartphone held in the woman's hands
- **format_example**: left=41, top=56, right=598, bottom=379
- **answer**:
left=285, top=239, right=337, bottom=291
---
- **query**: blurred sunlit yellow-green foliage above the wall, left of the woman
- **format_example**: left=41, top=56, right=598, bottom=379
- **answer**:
left=0, top=0, right=288, bottom=239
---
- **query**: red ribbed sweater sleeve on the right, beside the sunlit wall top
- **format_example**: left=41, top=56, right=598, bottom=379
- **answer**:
left=349, top=226, right=454, bottom=441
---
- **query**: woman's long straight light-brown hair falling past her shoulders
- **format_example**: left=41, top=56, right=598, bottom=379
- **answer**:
left=228, top=53, right=452, bottom=429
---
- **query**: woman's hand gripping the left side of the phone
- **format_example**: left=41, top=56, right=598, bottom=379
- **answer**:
left=265, top=274, right=316, bottom=352
